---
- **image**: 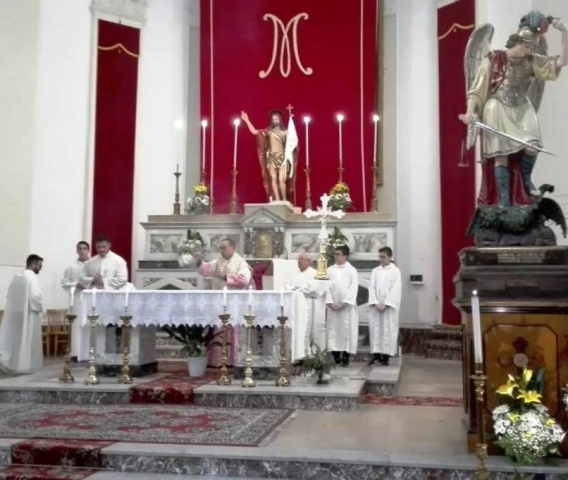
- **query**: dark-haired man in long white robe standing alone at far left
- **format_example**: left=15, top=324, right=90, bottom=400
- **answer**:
left=0, top=254, right=43, bottom=375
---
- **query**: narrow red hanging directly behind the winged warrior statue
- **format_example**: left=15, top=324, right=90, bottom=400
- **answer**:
left=438, top=0, right=475, bottom=324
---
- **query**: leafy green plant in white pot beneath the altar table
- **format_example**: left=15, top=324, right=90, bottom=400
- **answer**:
left=163, top=325, right=222, bottom=377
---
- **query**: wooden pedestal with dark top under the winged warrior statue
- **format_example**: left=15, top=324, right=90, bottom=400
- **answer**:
left=454, top=247, right=568, bottom=452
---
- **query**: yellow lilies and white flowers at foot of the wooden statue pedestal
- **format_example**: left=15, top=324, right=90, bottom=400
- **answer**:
left=493, top=368, right=565, bottom=465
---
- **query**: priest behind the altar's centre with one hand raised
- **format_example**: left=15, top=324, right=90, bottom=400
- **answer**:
left=198, top=238, right=253, bottom=366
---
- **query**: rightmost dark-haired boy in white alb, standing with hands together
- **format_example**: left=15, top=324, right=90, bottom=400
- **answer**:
left=369, top=247, right=402, bottom=365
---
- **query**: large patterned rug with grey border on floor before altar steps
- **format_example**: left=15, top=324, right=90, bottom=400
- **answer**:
left=0, top=404, right=293, bottom=446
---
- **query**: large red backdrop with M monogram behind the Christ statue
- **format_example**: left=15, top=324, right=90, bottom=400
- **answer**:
left=202, top=0, right=377, bottom=213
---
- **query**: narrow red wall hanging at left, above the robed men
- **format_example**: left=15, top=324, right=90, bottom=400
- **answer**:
left=93, top=20, right=140, bottom=265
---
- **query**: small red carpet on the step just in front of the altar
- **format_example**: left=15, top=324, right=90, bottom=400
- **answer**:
left=130, top=372, right=218, bottom=405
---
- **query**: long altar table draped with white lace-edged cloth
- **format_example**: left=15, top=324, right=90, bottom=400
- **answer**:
left=80, top=290, right=307, bottom=373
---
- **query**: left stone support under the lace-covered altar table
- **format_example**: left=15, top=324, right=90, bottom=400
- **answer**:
left=96, top=325, right=158, bottom=377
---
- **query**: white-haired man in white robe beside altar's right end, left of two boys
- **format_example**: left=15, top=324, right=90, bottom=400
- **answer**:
left=292, top=253, right=327, bottom=353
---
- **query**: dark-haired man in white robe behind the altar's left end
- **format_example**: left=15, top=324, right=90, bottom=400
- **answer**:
left=77, top=235, right=135, bottom=361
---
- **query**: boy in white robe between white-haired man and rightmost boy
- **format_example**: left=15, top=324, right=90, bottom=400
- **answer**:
left=326, top=246, right=359, bottom=367
